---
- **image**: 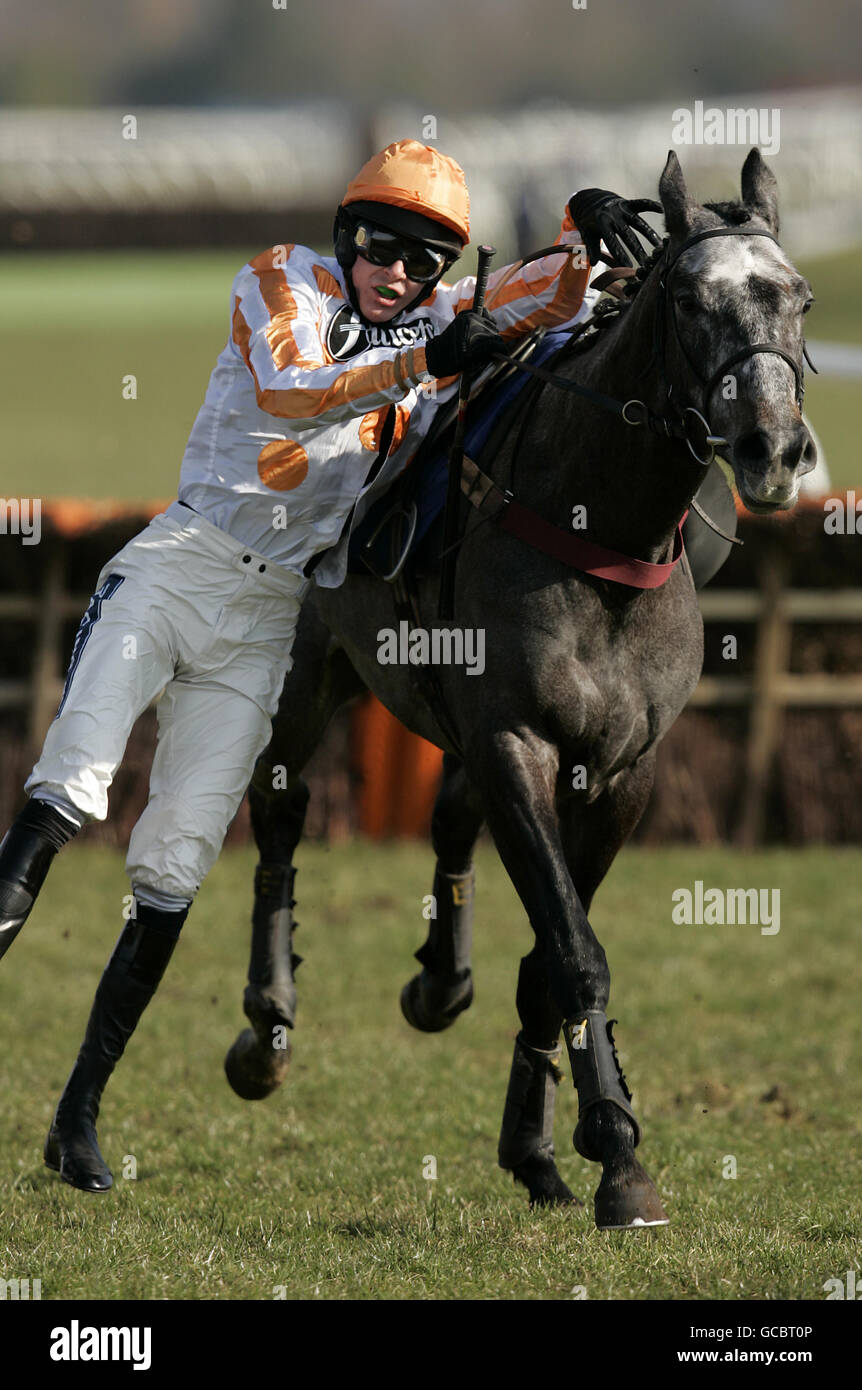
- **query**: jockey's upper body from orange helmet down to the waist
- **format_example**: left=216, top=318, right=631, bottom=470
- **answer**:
left=190, top=140, right=606, bottom=588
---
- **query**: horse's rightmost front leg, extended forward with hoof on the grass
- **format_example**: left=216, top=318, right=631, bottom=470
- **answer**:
left=469, top=731, right=667, bottom=1229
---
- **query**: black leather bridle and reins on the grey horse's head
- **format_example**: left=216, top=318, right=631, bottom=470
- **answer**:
left=495, top=227, right=816, bottom=468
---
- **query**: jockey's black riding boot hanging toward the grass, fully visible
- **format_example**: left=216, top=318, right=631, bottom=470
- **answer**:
left=44, top=904, right=188, bottom=1193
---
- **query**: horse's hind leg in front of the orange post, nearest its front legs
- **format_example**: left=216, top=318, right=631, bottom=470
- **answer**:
left=400, top=753, right=484, bottom=1033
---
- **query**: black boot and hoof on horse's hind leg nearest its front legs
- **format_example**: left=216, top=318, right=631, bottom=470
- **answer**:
left=400, top=866, right=474, bottom=1033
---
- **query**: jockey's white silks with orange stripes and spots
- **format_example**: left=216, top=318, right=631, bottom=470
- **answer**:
left=179, top=213, right=596, bottom=588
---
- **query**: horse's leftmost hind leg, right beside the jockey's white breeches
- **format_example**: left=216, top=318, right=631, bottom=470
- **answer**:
left=225, top=607, right=364, bottom=1101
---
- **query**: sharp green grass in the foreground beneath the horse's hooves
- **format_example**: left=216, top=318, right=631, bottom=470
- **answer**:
left=0, top=842, right=862, bottom=1301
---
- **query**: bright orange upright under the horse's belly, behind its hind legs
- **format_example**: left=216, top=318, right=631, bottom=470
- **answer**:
left=353, top=695, right=444, bottom=840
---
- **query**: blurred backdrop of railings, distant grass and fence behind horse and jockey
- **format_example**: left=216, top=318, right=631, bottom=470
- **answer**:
left=0, top=0, right=862, bottom=844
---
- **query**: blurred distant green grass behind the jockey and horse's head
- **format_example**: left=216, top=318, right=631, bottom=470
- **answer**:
left=0, top=247, right=862, bottom=500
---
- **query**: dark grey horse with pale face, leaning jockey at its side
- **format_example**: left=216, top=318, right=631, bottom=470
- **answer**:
left=225, top=150, right=816, bottom=1229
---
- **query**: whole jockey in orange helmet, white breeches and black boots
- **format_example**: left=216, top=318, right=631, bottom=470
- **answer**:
left=0, top=140, right=653, bottom=1191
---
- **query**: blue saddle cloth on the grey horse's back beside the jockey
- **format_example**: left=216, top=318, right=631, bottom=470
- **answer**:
left=348, top=329, right=570, bottom=574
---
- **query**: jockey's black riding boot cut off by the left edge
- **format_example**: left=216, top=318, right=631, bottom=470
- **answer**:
left=0, top=796, right=78, bottom=958
